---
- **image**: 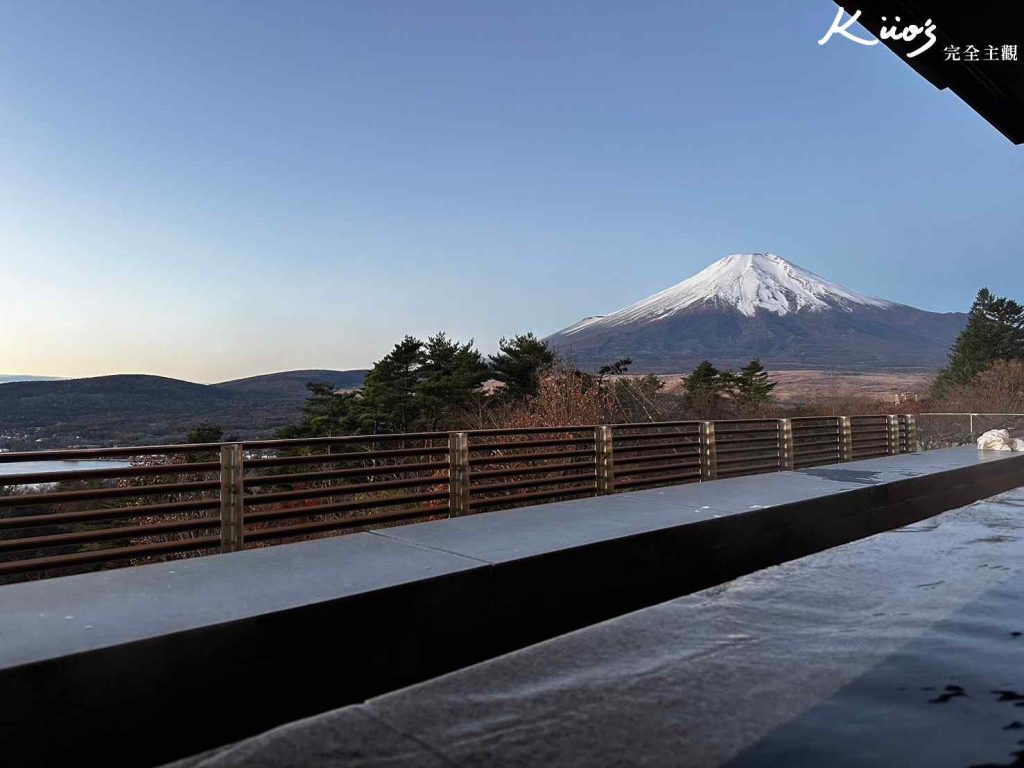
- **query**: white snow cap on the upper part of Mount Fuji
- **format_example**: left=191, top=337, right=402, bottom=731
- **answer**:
left=562, top=253, right=895, bottom=333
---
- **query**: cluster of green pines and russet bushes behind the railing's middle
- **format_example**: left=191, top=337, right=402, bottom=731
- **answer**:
left=275, top=333, right=775, bottom=438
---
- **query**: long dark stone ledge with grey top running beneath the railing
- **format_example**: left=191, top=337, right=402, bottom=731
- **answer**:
left=0, top=449, right=1024, bottom=766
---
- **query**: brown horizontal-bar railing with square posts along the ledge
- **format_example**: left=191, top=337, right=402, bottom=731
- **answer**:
left=0, top=415, right=916, bottom=582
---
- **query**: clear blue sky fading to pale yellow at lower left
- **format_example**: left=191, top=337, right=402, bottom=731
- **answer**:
left=0, top=0, right=1024, bottom=381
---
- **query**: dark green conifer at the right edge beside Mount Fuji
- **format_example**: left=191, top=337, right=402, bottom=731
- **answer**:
left=932, top=288, right=1024, bottom=397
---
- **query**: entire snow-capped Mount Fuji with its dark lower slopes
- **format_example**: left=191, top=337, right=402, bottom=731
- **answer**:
left=547, top=253, right=967, bottom=373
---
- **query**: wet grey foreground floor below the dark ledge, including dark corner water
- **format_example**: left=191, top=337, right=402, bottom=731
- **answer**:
left=167, top=488, right=1024, bottom=768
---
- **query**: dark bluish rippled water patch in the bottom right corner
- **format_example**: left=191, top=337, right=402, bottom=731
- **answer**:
left=730, top=565, right=1024, bottom=766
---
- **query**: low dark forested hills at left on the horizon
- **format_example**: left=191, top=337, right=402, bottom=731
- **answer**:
left=0, top=370, right=367, bottom=450
